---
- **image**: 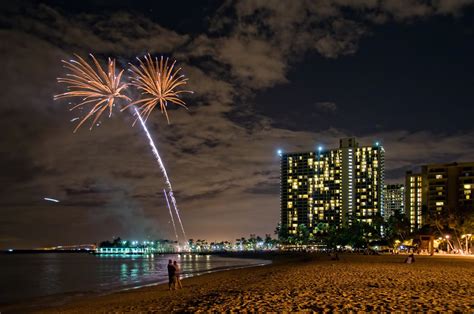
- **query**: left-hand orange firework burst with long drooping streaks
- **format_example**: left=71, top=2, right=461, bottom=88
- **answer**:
left=54, top=54, right=131, bottom=132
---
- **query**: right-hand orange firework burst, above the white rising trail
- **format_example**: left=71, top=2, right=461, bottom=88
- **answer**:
left=122, top=54, right=192, bottom=124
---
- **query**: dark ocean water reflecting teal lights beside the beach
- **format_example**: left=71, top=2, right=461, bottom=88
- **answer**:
left=0, top=253, right=269, bottom=304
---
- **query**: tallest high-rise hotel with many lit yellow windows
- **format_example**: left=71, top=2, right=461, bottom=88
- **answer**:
left=281, top=138, right=384, bottom=234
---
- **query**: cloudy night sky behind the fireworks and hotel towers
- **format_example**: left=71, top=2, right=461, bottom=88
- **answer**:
left=0, top=0, right=474, bottom=248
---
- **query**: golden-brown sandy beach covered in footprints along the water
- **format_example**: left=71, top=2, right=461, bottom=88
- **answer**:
left=5, top=255, right=474, bottom=313
